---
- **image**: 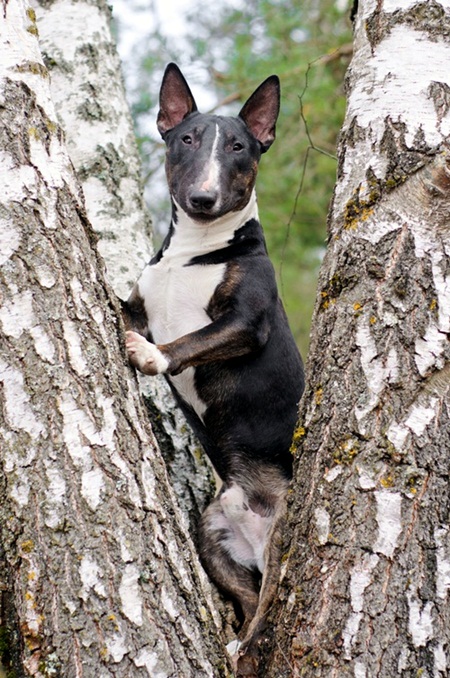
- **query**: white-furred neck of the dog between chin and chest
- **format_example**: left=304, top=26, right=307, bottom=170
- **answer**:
left=165, top=190, right=259, bottom=257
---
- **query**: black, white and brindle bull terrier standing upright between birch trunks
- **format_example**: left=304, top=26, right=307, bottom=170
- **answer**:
left=124, top=64, right=304, bottom=675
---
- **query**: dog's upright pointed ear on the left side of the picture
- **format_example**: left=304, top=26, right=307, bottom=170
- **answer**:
left=156, top=64, right=197, bottom=138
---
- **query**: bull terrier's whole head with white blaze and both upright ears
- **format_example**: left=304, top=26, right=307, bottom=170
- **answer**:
left=157, top=64, right=280, bottom=222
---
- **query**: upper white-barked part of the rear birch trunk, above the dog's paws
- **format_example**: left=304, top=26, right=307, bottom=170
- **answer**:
left=32, top=0, right=152, bottom=299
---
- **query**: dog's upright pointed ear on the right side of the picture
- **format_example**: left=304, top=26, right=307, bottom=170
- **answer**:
left=239, top=75, right=280, bottom=153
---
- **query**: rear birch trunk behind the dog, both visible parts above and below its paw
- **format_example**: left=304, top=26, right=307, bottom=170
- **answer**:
left=33, top=0, right=214, bottom=534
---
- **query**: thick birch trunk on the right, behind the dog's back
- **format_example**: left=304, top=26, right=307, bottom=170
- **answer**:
left=261, top=0, right=450, bottom=678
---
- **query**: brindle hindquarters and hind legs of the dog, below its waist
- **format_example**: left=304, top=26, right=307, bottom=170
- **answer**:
left=200, top=476, right=288, bottom=678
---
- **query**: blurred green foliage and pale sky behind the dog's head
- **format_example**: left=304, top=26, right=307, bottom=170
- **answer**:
left=121, top=0, right=351, bottom=354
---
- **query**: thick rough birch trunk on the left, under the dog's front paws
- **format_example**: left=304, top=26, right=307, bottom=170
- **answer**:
left=0, top=0, right=228, bottom=678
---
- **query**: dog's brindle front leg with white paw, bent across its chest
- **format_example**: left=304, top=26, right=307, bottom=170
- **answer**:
left=126, top=314, right=269, bottom=375
